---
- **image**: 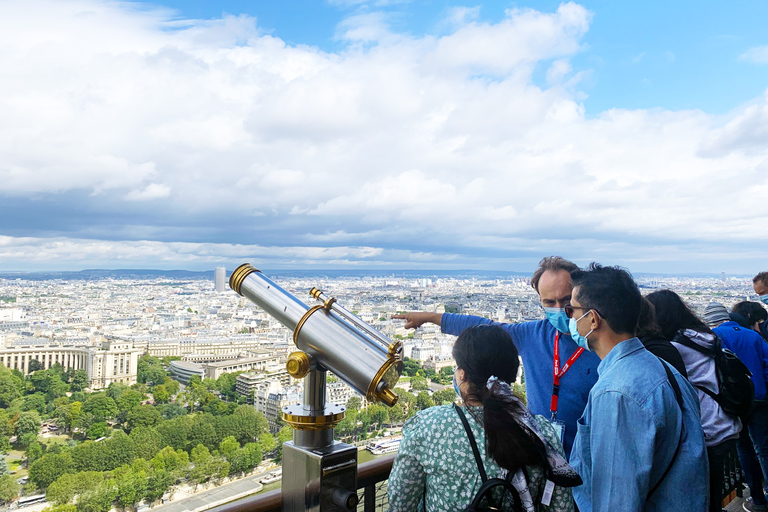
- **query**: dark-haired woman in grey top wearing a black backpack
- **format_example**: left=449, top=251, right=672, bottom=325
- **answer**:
left=646, top=290, right=741, bottom=512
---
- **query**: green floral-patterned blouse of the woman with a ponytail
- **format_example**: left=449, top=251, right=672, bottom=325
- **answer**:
left=387, top=405, right=574, bottom=512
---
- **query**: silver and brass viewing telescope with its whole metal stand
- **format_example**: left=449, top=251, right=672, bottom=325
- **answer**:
left=229, top=263, right=403, bottom=512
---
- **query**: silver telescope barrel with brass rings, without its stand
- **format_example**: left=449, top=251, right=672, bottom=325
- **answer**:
left=229, top=264, right=402, bottom=406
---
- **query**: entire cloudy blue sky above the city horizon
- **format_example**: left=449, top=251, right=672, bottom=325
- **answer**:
left=0, top=0, right=768, bottom=274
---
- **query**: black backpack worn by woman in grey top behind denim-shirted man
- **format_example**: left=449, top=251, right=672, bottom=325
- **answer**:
left=672, top=332, right=755, bottom=418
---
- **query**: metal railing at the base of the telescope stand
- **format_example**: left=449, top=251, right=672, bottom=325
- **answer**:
left=207, top=453, right=397, bottom=512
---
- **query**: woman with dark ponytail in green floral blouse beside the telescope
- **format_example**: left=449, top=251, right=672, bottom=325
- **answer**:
left=387, top=325, right=581, bottom=512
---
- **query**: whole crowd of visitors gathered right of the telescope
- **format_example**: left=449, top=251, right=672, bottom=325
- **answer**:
left=388, top=256, right=768, bottom=512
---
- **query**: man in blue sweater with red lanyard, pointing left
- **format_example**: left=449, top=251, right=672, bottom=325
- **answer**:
left=392, top=256, right=600, bottom=456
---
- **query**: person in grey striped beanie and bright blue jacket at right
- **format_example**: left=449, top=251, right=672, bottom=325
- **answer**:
left=704, top=302, right=768, bottom=512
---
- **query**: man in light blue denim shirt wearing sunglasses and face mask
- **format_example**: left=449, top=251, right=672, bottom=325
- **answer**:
left=566, top=263, right=709, bottom=512
